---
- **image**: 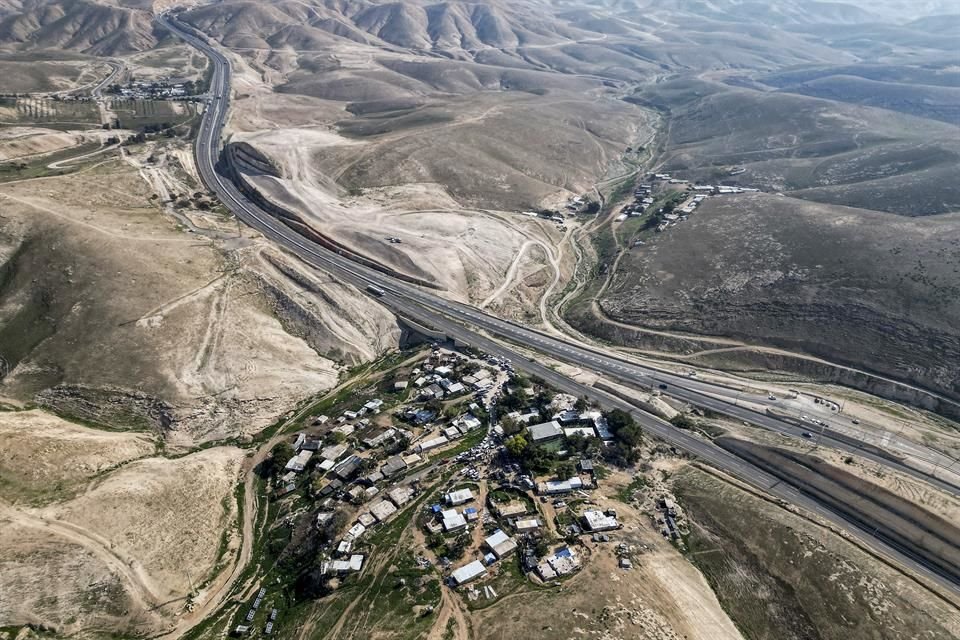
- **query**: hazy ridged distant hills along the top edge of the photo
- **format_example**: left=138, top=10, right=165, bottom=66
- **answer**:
left=0, top=0, right=960, bottom=62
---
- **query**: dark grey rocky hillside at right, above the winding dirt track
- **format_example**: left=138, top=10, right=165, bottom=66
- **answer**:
left=600, top=194, right=960, bottom=397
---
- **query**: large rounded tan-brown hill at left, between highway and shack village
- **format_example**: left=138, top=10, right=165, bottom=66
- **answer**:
left=0, top=134, right=399, bottom=444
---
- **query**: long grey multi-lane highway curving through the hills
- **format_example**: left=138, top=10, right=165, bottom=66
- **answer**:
left=157, top=14, right=960, bottom=596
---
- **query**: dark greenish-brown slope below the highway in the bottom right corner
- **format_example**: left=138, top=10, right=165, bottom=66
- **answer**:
left=673, top=468, right=960, bottom=639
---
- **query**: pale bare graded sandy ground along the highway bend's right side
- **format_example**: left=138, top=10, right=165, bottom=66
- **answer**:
left=235, top=129, right=562, bottom=308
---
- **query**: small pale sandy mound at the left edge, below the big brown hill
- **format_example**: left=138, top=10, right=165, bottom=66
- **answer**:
left=0, top=410, right=156, bottom=501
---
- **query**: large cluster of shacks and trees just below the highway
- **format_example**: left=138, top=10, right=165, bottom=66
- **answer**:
left=233, top=348, right=676, bottom=635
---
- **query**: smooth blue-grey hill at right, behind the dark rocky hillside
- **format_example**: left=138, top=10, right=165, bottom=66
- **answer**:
left=632, top=79, right=960, bottom=216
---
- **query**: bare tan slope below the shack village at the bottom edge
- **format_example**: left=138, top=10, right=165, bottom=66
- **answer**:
left=471, top=464, right=743, bottom=640
